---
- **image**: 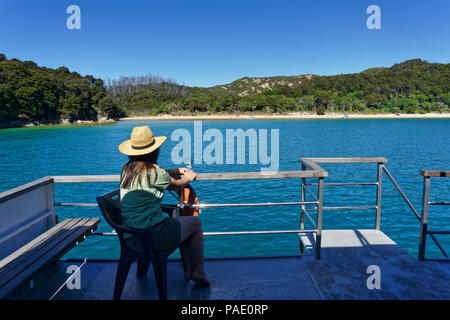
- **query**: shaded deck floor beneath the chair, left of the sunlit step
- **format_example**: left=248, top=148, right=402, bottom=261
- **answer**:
left=15, top=257, right=320, bottom=300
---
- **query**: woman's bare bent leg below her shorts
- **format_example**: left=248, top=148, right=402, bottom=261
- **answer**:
left=176, top=216, right=209, bottom=285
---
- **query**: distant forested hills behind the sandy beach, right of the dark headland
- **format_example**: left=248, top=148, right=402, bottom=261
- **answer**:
left=107, top=59, right=450, bottom=115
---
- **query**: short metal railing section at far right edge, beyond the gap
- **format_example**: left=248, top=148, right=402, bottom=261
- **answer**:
left=419, top=170, right=450, bottom=261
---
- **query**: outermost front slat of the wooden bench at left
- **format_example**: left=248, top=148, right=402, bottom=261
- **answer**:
left=0, top=218, right=100, bottom=299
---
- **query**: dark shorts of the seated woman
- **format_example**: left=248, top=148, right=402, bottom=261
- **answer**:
left=125, top=218, right=181, bottom=252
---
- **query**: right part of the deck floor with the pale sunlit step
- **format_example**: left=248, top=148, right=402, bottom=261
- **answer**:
left=305, top=230, right=450, bottom=300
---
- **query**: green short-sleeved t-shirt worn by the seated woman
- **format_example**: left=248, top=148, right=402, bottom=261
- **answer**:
left=120, top=165, right=172, bottom=238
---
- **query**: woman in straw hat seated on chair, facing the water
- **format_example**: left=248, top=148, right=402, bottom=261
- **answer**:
left=119, top=126, right=210, bottom=286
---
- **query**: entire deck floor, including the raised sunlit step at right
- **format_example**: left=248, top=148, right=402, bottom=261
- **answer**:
left=8, top=230, right=450, bottom=300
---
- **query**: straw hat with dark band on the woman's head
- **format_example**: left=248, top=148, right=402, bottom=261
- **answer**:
left=119, top=126, right=166, bottom=156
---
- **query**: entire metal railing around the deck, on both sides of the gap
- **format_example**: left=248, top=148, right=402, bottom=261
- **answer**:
left=43, top=157, right=450, bottom=260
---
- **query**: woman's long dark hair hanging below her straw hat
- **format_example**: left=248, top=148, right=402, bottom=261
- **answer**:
left=120, top=148, right=159, bottom=189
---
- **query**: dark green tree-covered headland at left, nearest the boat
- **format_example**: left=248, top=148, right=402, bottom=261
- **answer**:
left=0, top=54, right=121, bottom=122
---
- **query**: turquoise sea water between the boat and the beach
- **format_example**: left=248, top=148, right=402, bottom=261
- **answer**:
left=0, top=119, right=450, bottom=258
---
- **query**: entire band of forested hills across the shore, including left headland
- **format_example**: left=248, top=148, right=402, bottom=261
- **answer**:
left=0, top=54, right=450, bottom=123
